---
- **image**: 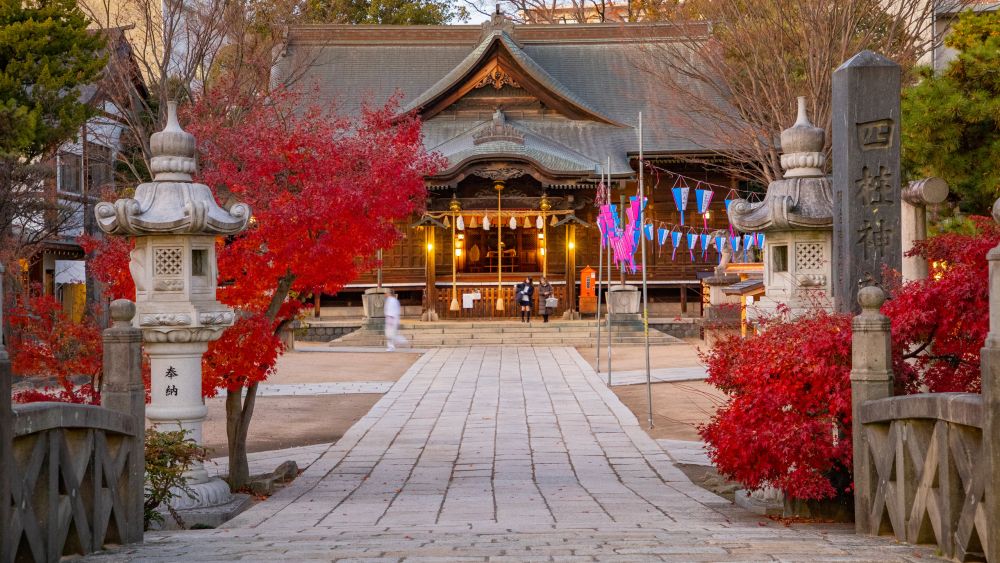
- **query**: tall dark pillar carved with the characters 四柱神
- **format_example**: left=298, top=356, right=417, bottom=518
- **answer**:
left=833, top=51, right=902, bottom=313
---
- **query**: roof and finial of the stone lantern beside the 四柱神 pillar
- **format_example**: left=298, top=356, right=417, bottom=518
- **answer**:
left=729, top=97, right=833, bottom=232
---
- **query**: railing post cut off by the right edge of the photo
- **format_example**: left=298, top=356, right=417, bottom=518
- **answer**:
left=981, top=200, right=1000, bottom=562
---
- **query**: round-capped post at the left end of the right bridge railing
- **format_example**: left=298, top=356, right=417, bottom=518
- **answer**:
left=851, top=286, right=892, bottom=534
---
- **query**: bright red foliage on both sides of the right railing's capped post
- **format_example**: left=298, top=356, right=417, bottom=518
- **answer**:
left=700, top=217, right=1000, bottom=499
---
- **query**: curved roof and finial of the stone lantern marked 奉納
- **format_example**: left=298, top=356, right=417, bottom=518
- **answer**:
left=94, top=102, right=250, bottom=236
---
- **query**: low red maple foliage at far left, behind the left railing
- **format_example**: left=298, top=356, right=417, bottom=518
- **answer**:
left=7, top=292, right=103, bottom=404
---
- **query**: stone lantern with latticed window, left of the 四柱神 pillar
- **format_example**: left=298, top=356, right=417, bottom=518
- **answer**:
left=729, top=97, right=833, bottom=315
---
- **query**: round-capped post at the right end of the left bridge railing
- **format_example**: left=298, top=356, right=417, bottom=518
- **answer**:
left=101, top=299, right=146, bottom=543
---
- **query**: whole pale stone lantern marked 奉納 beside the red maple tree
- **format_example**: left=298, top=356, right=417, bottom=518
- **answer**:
left=94, top=102, right=250, bottom=509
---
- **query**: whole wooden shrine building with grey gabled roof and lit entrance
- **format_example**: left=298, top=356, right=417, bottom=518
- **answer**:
left=276, top=14, right=739, bottom=319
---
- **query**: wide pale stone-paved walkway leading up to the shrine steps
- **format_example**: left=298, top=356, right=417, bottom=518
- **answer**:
left=95, top=348, right=933, bottom=561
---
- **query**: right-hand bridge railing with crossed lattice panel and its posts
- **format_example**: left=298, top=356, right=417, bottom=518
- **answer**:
left=851, top=286, right=1000, bottom=563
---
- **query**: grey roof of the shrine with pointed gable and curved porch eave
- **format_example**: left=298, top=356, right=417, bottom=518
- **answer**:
left=276, top=23, right=725, bottom=176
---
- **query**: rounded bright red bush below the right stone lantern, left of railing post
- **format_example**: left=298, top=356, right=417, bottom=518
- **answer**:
left=701, top=310, right=851, bottom=498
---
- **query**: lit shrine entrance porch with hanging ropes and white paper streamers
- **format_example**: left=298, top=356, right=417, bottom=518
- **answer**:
left=417, top=162, right=594, bottom=319
